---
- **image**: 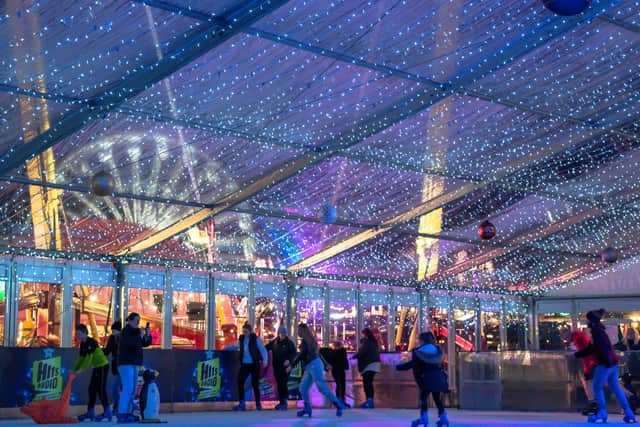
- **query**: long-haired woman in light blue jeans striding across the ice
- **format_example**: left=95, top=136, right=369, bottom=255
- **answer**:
left=294, top=323, right=344, bottom=417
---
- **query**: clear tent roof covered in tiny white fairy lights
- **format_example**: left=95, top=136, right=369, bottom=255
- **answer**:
left=0, top=0, right=640, bottom=306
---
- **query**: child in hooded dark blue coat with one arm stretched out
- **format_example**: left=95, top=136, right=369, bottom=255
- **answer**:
left=396, top=332, right=449, bottom=427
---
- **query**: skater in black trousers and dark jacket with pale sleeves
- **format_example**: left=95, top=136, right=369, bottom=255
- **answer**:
left=233, top=323, right=269, bottom=411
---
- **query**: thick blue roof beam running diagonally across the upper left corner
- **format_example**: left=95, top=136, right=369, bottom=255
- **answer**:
left=0, top=0, right=287, bottom=175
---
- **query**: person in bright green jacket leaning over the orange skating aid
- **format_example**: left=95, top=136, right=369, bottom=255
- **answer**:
left=72, top=324, right=113, bottom=421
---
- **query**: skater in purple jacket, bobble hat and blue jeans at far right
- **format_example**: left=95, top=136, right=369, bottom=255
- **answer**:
left=575, top=308, right=636, bottom=424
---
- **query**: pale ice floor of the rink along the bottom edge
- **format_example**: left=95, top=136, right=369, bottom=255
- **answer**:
left=0, top=409, right=624, bottom=427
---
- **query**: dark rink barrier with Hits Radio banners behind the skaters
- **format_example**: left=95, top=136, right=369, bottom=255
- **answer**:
left=0, top=347, right=438, bottom=418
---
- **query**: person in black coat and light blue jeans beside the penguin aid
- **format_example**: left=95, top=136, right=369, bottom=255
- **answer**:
left=118, top=313, right=151, bottom=423
